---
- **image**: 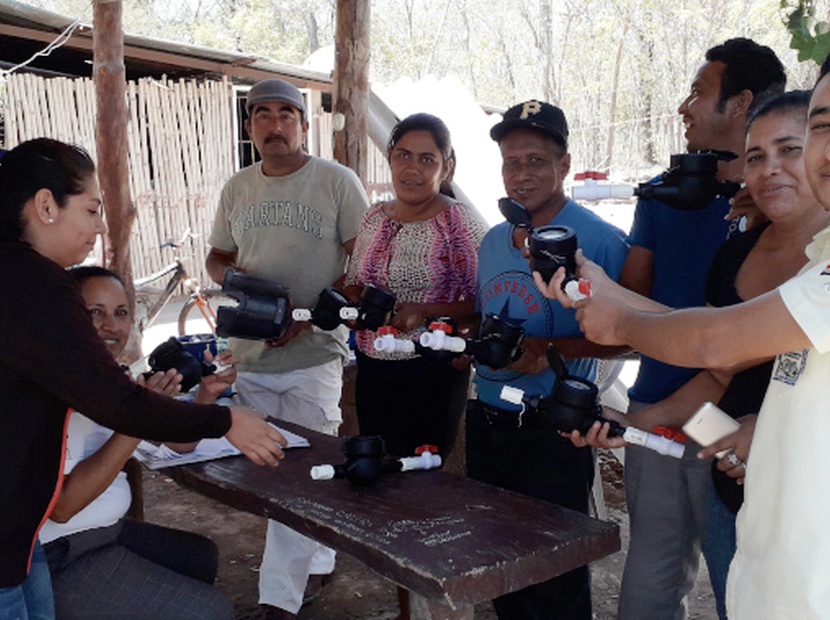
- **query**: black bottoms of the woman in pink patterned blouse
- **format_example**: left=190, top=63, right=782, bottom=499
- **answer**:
left=355, top=352, right=470, bottom=457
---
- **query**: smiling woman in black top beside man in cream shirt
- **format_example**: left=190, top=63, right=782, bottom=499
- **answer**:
left=702, top=91, right=830, bottom=620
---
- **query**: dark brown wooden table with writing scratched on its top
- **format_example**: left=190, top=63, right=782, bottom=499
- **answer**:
left=165, top=423, right=620, bottom=619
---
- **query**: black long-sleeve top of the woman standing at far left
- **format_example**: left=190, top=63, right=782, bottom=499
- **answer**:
left=0, top=242, right=230, bottom=588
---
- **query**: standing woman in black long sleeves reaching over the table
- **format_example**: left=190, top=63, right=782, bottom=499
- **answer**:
left=0, top=138, right=284, bottom=618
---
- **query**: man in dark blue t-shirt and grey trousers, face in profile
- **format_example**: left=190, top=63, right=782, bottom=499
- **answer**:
left=618, top=39, right=786, bottom=620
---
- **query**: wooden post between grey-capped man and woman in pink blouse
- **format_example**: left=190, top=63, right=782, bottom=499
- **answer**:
left=334, top=0, right=371, bottom=185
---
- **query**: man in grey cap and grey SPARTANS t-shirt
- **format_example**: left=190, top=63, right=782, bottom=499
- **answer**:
left=207, top=79, right=368, bottom=619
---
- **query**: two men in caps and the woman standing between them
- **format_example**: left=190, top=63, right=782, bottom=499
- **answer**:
left=208, top=75, right=627, bottom=618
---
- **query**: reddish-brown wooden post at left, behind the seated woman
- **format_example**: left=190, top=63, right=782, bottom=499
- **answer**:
left=92, top=0, right=140, bottom=357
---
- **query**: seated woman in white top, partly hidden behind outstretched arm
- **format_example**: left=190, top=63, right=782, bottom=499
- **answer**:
left=40, top=267, right=234, bottom=620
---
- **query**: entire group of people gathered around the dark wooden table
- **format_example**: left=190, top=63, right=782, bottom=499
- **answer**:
left=0, top=39, right=830, bottom=620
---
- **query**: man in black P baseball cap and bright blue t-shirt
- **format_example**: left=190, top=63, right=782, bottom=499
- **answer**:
left=466, top=100, right=628, bottom=620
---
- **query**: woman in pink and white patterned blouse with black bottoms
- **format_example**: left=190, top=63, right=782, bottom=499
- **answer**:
left=346, top=114, right=486, bottom=456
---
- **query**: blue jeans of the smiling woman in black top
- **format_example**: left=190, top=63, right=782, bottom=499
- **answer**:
left=703, top=489, right=737, bottom=620
